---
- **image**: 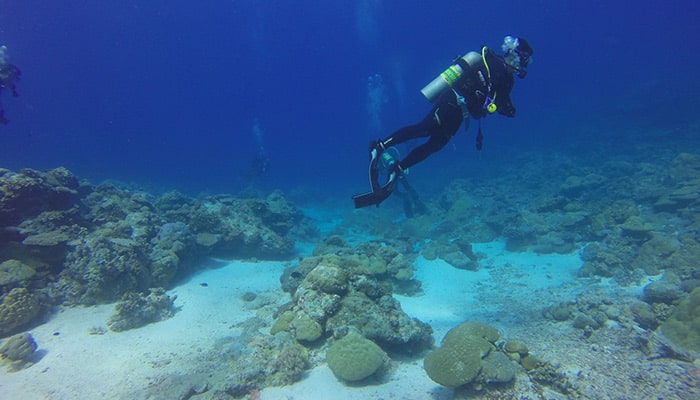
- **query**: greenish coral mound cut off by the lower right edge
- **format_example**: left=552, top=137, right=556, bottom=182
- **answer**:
left=661, top=288, right=700, bottom=352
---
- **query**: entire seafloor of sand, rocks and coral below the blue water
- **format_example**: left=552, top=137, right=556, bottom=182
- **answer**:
left=0, top=122, right=700, bottom=400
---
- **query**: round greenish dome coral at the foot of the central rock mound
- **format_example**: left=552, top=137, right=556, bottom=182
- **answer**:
left=326, top=331, right=386, bottom=382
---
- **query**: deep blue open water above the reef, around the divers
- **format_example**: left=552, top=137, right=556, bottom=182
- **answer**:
left=0, top=0, right=700, bottom=197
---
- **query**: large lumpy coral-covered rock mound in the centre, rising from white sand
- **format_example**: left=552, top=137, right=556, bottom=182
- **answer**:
left=274, top=237, right=432, bottom=353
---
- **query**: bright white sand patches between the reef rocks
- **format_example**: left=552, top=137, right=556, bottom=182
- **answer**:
left=0, top=243, right=580, bottom=400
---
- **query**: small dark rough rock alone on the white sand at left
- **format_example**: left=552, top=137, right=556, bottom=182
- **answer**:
left=107, top=288, right=177, bottom=332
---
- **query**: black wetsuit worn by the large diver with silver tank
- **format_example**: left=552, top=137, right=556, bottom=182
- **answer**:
left=383, top=49, right=515, bottom=169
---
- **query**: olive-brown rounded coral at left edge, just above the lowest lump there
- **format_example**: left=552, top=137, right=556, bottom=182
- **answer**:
left=0, top=288, right=41, bottom=336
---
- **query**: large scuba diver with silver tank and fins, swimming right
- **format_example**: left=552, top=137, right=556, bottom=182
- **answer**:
left=353, top=36, right=534, bottom=208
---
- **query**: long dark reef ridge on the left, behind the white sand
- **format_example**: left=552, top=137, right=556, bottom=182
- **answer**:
left=0, top=168, right=313, bottom=335
